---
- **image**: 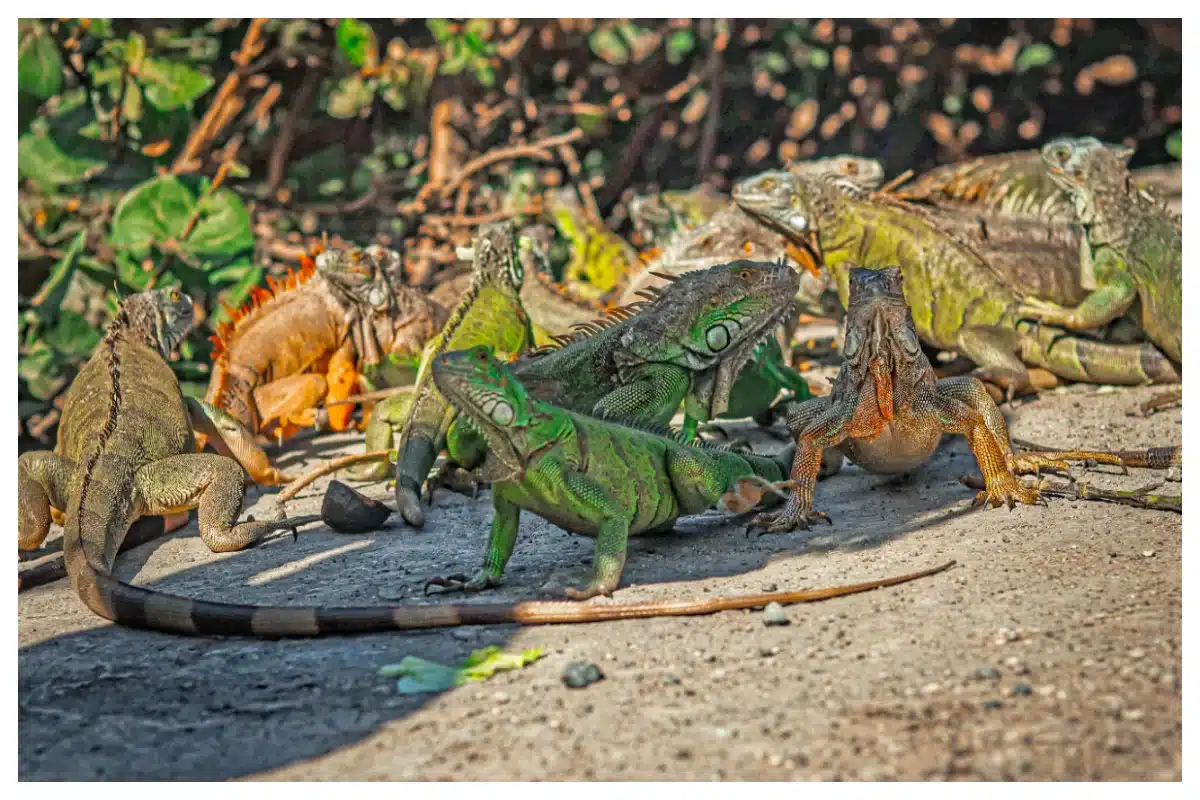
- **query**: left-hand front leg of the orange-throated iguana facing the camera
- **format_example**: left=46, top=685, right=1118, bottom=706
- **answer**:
left=750, top=395, right=853, bottom=533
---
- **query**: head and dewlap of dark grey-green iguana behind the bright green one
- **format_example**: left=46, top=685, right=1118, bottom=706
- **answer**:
left=613, top=260, right=800, bottom=419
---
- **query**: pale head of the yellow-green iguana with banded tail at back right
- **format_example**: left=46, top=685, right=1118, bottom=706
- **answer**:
left=733, top=169, right=821, bottom=269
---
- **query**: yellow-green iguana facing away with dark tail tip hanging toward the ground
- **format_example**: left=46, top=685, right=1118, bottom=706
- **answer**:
left=352, top=223, right=533, bottom=528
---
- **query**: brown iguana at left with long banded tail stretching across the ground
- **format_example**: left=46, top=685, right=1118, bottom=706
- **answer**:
left=17, top=289, right=953, bottom=638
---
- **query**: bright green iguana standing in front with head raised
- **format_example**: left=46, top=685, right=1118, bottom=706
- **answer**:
left=433, top=347, right=784, bottom=600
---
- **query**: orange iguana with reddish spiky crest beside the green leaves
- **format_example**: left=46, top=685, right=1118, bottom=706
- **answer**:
left=205, top=246, right=446, bottom=470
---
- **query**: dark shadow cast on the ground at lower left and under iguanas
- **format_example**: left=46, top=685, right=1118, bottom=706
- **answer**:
left=18, top=434, right=998, bottom=780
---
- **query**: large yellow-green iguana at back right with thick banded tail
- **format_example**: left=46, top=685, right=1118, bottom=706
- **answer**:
left=733, top=172, right=1178, bottom=398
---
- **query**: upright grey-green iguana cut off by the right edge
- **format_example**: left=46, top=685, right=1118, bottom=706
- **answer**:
left=1020, top=137, right=1183, bottom=367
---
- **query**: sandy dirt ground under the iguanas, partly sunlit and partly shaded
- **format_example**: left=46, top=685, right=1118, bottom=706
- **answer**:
left=19, top=386, right=1182, bottom=781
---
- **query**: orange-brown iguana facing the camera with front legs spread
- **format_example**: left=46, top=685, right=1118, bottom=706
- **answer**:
left=751, top=266, right=1121, bottom=531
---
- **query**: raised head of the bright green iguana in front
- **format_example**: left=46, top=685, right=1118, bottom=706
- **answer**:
left=431, top=344, right=535, bottom=482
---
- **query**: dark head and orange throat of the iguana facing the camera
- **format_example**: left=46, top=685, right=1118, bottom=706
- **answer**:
left=842, top=266, right=931, bottom=420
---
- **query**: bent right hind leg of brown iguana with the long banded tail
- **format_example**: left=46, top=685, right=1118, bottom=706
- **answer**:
left=133, top=453, right=320, bottom=553
